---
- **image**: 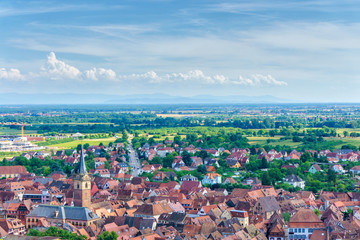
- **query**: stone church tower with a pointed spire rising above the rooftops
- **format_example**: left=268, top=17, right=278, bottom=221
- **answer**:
left=73, top=146, right=91, bottom=208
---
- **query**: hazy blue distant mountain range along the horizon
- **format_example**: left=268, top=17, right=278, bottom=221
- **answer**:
left=0, top=93, right=297, bottom=105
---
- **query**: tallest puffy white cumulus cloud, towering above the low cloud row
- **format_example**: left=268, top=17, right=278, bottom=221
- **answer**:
left=41, top=52, right=81, bottom=80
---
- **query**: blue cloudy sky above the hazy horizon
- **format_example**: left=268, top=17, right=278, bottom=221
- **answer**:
left=0, top=0, right=360, bottom=102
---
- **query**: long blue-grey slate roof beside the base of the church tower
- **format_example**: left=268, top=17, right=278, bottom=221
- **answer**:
left=28, top=204, right=99, bottom=221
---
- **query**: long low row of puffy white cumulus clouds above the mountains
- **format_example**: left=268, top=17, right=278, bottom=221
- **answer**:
left=0, top=52, right=287, bottom=87
